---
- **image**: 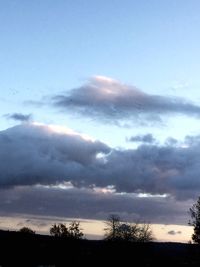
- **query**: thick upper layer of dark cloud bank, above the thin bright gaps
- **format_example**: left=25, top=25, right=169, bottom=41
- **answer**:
left=0, top=124, right=200, bottom=199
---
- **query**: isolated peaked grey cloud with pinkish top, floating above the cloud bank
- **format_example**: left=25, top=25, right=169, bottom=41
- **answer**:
left=52, top=76, right=200, bottom=124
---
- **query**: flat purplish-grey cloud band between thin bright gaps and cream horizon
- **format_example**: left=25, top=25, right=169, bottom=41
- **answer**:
left=0, top=186, right=192, bottom=224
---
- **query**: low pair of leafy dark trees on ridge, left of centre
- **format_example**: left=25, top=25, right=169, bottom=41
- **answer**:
left=50, top=221, right=84, bottom=239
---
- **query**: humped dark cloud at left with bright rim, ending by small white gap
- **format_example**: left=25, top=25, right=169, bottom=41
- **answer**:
left=0, top=123, right=110, bottom=186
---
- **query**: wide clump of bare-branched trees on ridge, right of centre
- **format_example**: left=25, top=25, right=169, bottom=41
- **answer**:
left=104, top=215, right=154, bottom=242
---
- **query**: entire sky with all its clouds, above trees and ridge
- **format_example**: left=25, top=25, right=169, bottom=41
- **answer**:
left=0, top=0, right=200, bottom=242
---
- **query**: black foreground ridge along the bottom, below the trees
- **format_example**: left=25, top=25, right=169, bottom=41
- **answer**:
left=0, top=231, right=200, bottom=267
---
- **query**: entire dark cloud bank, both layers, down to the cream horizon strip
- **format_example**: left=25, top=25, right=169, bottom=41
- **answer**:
left=0, top=123, right=200, bottom=224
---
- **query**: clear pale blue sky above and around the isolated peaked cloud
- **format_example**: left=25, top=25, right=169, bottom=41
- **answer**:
left=0, top=1, right=200, bottom=145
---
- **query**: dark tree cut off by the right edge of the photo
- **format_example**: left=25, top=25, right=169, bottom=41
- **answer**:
left=188, top=197, right=200, bottom=244
